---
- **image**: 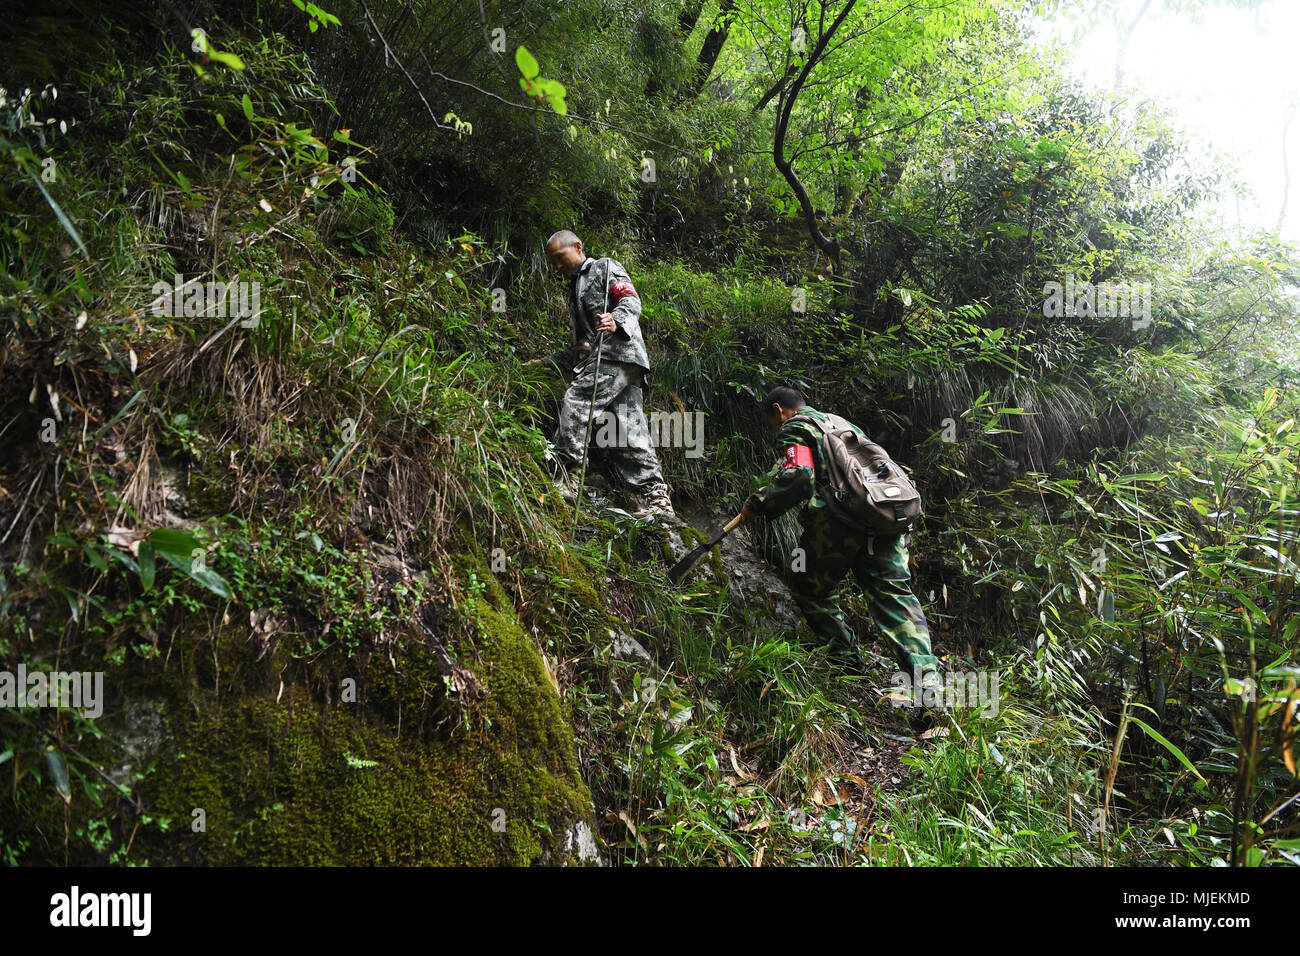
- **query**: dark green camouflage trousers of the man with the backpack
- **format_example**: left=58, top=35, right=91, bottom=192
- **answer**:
left=787, top=509, right=939, bottom=674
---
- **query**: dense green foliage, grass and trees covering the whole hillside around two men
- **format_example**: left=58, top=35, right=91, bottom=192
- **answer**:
left=0, top=0, right=1300, bottom=865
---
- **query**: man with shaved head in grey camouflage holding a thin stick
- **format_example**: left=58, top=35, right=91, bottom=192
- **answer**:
left=546, top=229, right=676, bottom=522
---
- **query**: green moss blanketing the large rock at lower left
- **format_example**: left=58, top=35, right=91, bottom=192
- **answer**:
left=126, top=578, right=590, bottom=865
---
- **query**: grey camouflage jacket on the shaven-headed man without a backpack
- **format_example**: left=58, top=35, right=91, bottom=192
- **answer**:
left=551, top=256, right=650, bottom=372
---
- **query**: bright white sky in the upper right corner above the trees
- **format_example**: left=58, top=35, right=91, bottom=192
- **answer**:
left=1043, top=0, right=1300, bottom=247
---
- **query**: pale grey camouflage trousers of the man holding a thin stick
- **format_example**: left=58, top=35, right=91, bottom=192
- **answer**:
left=553, top=360, right=664, bottom=493
